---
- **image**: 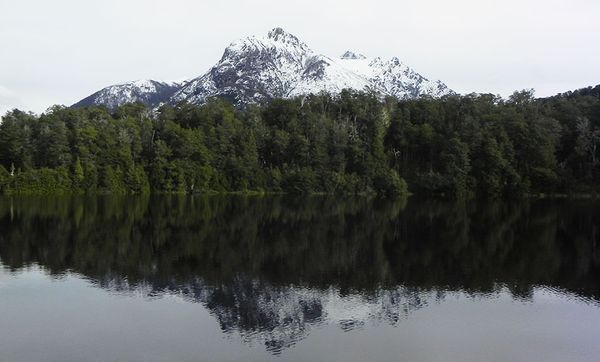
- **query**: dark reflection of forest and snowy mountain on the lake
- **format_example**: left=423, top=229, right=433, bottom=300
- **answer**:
left=0, top=196, right=600, bottom=354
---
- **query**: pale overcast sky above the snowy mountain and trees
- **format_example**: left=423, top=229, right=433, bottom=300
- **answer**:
left=0, top=0, right=600, bottom=114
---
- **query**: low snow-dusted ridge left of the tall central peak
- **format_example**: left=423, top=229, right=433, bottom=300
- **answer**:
left=73, top=80, right=181, bottom=109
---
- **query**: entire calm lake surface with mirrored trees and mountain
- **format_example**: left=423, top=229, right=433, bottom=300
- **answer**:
left=0, top=197, right=600, bottom=361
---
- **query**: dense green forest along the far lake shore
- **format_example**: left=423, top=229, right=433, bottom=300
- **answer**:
left=0, top=86, right=600, bottom=196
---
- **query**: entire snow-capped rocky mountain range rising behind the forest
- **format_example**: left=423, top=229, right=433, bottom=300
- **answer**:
left=75, top=28, right=453, bottom=108
